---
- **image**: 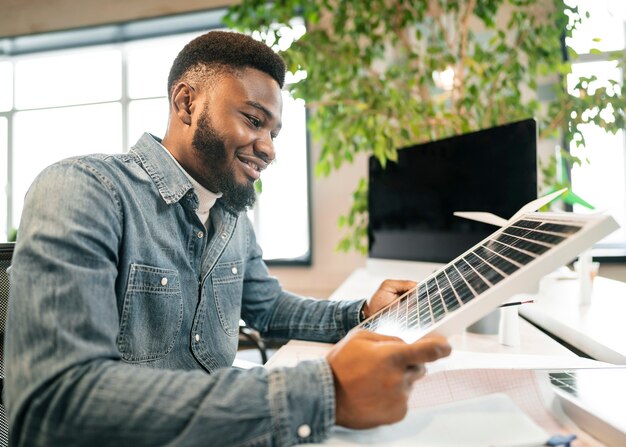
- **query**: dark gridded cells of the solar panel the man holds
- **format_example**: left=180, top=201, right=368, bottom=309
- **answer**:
left=361, top=213, right=616, bottom=340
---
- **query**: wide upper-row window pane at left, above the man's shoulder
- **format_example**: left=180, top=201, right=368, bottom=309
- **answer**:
left=15, top=48, right=122, bottom=109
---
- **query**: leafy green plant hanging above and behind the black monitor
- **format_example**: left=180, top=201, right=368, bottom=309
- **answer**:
left=226, top=0, right=626, bottom=252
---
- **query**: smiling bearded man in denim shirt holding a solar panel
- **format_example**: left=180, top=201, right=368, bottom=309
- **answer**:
left=1, top=32, right=450, bottom=446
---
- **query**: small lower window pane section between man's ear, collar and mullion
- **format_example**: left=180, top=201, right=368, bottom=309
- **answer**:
left=128, top=98, right=169, bottom=145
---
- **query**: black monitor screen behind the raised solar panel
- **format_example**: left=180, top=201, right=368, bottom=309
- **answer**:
left=368, top=119, right=537, bottom=262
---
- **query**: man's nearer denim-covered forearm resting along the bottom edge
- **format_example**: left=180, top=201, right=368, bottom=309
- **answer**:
left=12, top=360, right=334, bottom=447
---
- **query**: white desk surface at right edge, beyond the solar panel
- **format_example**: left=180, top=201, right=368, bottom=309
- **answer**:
left=519, top=275, right=626, bottom=365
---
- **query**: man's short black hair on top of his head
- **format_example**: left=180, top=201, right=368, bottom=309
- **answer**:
left=167, top=31, right=285, bottom=96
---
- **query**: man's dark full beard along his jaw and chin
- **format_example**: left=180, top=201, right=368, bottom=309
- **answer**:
left=192, top=109, right=256, bottom=212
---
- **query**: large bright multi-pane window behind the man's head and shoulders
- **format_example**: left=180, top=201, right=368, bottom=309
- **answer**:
left=0, top=11, right=311, bottom=263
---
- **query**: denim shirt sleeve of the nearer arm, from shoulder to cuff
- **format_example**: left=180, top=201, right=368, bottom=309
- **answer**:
left=5, top=161, right=335, bottom=447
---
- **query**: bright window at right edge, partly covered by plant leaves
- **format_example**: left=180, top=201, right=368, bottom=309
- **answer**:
left=566, top=0, right=626, bottom=259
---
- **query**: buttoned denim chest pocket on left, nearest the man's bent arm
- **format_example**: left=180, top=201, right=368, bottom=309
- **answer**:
left=117, top=264, right=183, bottom=362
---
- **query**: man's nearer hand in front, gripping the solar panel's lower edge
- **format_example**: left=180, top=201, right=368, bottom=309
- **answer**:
left=326, top=330, right=451, bottom=428
